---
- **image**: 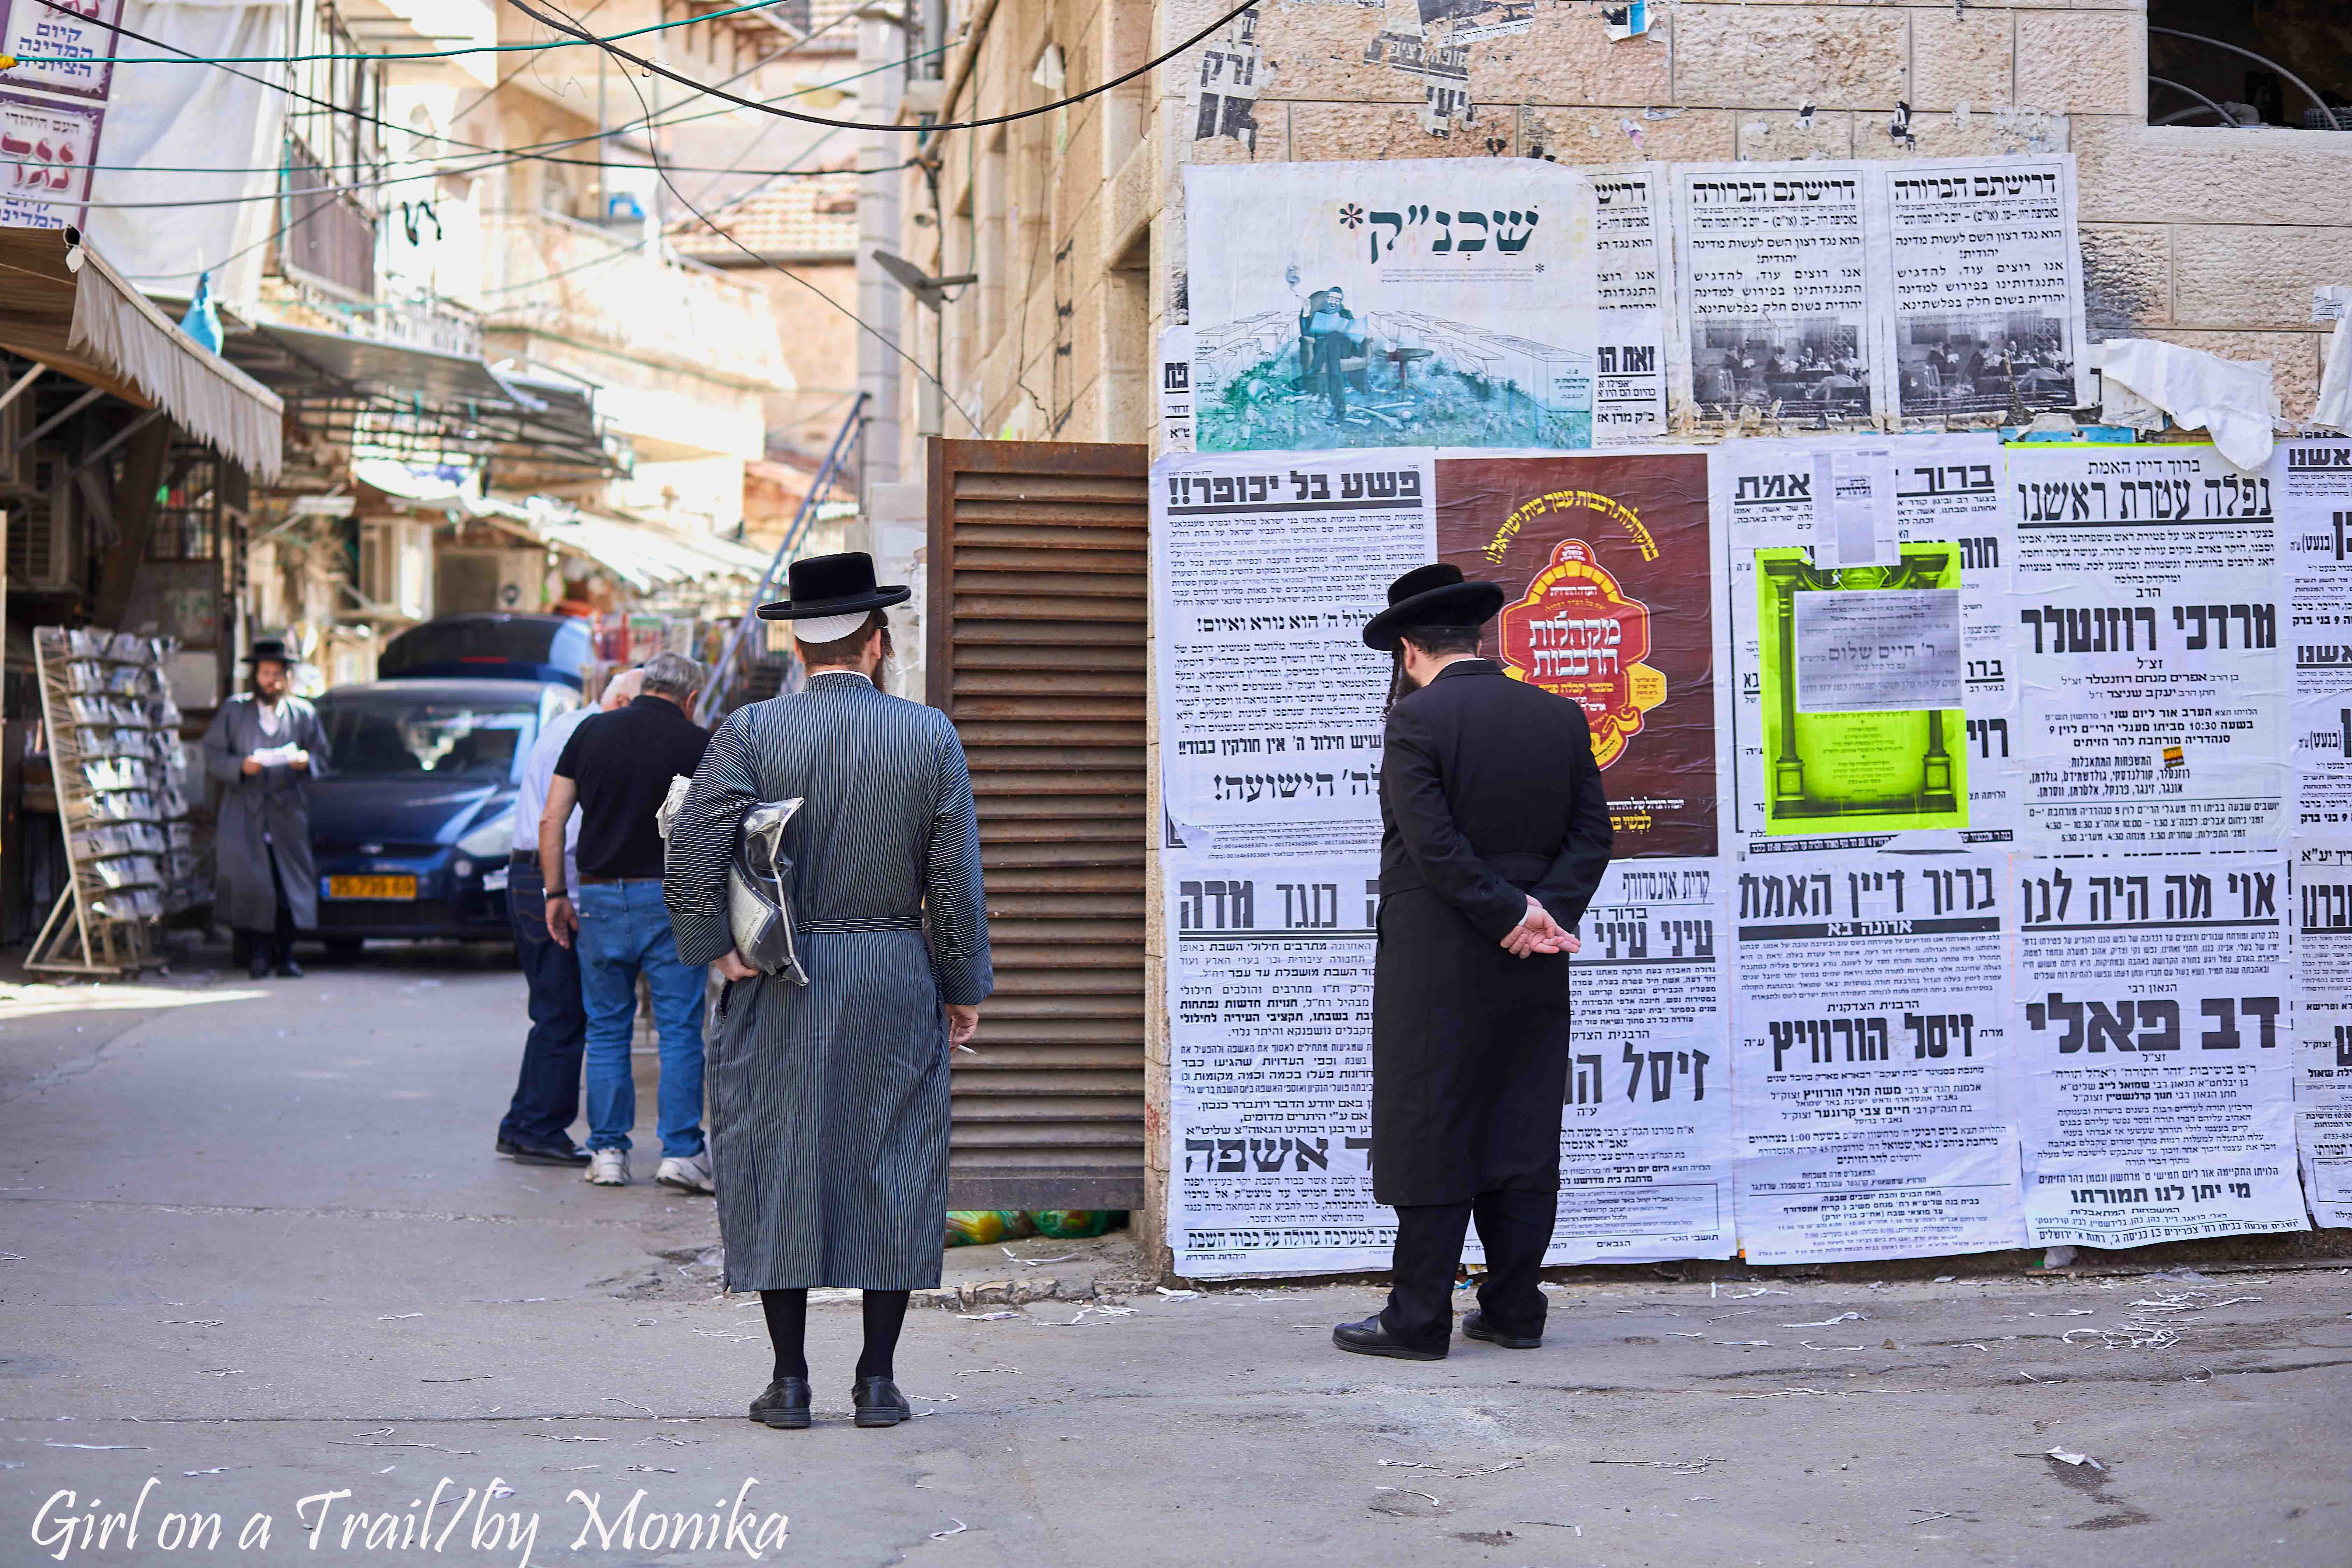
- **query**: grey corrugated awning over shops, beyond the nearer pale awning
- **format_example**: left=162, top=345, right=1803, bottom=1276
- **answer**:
left=221, top=322, right=618, bottom=472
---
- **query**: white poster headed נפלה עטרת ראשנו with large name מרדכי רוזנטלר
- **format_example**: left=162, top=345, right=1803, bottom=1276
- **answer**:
left=2009, top=444, right=2289, bottom=853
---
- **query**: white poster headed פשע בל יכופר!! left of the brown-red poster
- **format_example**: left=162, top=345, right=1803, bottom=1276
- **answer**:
left=1150, top=449, right=1435, bottom=849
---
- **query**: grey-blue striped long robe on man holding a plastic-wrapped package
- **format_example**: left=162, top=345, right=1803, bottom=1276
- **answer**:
left=663, top=670, right=995, bottom=1290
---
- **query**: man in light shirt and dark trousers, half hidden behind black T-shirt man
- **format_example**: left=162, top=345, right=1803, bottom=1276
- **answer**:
left=499, top=670, right=644, bottom=1166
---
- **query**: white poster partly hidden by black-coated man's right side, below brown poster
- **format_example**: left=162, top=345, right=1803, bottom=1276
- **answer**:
left=1545, top=860, right=1734, bottom=1265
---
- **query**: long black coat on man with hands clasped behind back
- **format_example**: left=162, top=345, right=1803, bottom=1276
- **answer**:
left=1371, top=658, right=1609, bottom=1204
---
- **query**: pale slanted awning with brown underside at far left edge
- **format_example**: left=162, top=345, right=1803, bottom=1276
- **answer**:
left=0, top=228, right=285, bottom=482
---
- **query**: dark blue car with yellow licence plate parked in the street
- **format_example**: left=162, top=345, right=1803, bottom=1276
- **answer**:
left=308, top=677, right=581, bottom=954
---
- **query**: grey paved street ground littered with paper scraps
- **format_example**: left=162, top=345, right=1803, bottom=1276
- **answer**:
left=0, top=947, right=2352, bottom=1568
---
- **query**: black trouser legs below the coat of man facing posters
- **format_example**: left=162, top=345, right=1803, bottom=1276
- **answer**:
left=1381, top=1187, right=1559, bottom=1349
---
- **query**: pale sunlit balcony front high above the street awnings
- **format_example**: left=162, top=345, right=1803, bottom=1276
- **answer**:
left=482, top=211, right=790, bottom=388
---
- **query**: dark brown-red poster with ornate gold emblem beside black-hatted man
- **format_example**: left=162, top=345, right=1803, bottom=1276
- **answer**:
left=1437, top=451, right=1715, bottom=858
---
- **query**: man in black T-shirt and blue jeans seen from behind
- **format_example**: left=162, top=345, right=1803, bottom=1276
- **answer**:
left=539, top=653, right=710, bottom=1192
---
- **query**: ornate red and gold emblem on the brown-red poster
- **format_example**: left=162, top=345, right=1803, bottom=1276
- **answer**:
left=1500, top=538, right=1665, bottom=766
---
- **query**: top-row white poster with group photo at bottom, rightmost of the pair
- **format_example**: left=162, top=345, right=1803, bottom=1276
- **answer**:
left=1875, top=155, right=2088, bottom=421
